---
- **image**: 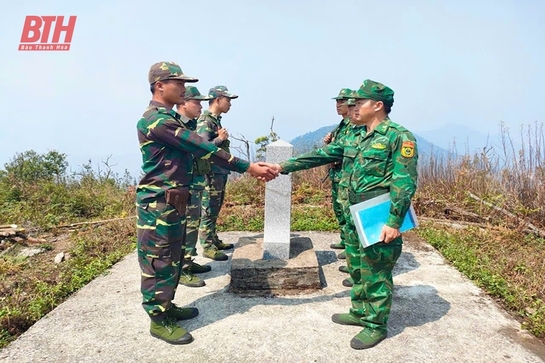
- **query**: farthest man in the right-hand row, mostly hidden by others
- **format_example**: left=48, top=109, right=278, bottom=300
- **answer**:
left=324, top=88, right=352, bottom=259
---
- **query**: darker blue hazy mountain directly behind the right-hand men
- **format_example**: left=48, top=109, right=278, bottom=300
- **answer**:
left=290, top=125, right=449, bottom=161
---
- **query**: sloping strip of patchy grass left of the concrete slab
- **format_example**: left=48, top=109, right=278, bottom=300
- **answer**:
left=0, top=219, right=135, bottom=347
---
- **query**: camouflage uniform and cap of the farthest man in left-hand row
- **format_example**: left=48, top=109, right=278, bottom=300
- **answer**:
left=197, top=86, right=238, bottom=252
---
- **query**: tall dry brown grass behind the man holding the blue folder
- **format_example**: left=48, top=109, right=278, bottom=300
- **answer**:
left=415, top=124, right=545, bottom=228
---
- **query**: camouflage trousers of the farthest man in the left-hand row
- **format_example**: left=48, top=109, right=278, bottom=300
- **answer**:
left=199, top=173, right=229, bottom=248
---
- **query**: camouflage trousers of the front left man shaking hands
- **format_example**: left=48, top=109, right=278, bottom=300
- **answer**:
left=136, top=199, right=185, bottom=320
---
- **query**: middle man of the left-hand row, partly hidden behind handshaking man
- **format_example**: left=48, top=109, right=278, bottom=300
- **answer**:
left=176, top=86, right=212, bottom=287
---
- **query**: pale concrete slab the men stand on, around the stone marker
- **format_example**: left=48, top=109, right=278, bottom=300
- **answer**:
left=0, top=231, right=545, bottom=363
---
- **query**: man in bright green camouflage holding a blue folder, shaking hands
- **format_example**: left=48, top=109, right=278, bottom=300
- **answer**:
left=270, top=80, right=418, bottom=349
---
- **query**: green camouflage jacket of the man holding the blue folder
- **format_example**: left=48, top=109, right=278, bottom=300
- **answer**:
left=280, top=118, right=418, bottom=228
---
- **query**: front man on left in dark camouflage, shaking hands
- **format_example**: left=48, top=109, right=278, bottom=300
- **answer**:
left=132, top=62, right=277, bottom=344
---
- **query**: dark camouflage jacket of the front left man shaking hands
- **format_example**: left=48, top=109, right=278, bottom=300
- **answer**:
left=136, top=101, right=250, bottom=203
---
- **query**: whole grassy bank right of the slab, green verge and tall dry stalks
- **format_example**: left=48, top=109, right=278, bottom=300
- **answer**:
left=414, top=124, right=545, bottom=339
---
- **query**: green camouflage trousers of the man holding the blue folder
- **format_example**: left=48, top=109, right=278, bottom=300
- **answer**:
left=345, top=196, right=403, bottom=331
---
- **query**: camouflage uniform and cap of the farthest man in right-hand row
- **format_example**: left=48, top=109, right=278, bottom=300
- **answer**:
left=329, top=88, right=352, bottom=248
